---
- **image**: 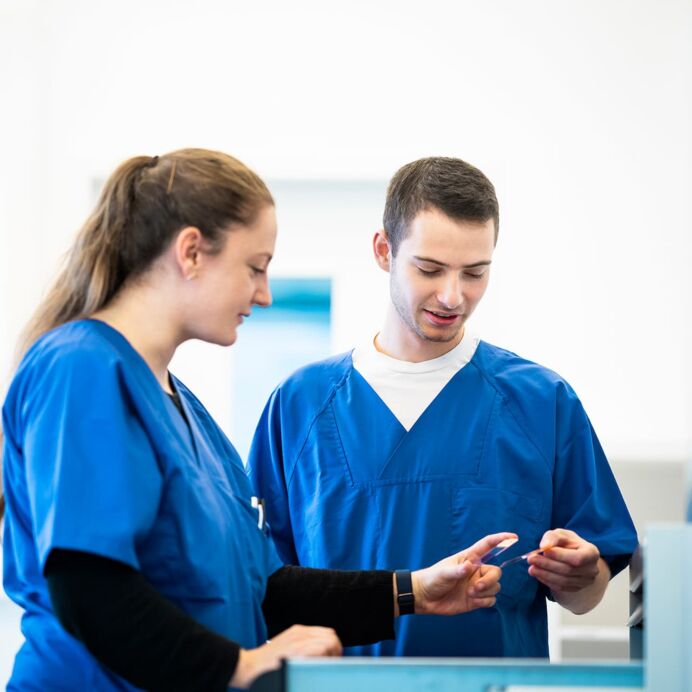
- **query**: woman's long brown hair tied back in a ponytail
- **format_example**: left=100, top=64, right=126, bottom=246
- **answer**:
left=0, top=149, right=274, bottom=519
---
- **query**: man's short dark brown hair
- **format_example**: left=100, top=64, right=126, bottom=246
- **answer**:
left=383, top=156, right=500, bottom=255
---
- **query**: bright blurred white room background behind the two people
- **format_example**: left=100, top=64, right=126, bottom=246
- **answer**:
left=0, top=0, right=692, bottom=682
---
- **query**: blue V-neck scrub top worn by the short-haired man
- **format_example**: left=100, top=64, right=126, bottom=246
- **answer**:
left=249, top=342, right=637, bottom=657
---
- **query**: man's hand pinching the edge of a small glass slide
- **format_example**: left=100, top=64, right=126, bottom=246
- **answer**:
left=527, top=529, right=610, bottom=614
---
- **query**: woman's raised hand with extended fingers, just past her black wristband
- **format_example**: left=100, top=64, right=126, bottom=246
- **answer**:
left=411, top=533, right=516, bottom=615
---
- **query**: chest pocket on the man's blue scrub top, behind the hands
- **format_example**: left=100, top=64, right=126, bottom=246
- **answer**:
left=451, top=487, right=543, bottom=608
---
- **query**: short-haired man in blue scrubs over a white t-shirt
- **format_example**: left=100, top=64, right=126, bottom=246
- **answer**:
left=250, top=158, right=637, bottom=657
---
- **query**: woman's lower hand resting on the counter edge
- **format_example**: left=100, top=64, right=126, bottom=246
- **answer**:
left=229, top=625, right=343, bottom=687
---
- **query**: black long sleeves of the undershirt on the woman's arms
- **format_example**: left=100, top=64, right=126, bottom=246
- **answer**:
left=45, top=549, right=394, bottom=692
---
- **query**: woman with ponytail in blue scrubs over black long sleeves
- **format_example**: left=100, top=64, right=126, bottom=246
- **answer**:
left=3, top=149, right=512, bottom=691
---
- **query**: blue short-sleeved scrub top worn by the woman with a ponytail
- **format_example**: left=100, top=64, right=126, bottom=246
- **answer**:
left=3, top=320, right=282, bottom=692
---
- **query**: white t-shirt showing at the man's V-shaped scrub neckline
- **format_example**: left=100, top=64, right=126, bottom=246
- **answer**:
left=352, top=334, right=479, bottom=430
